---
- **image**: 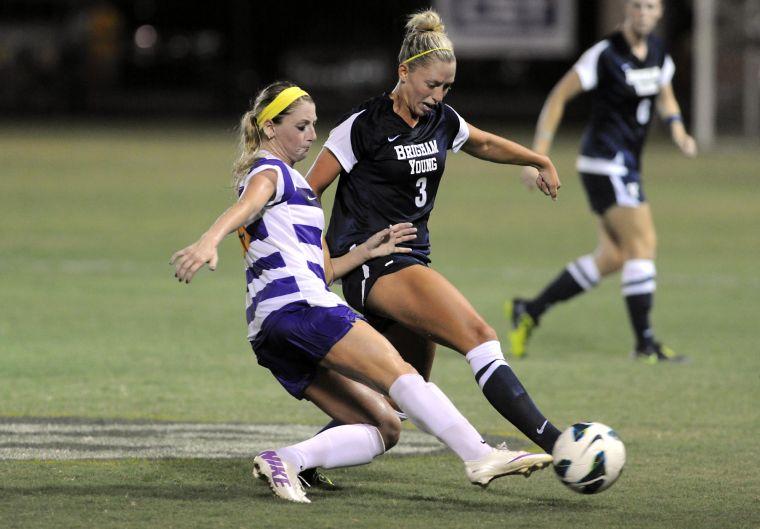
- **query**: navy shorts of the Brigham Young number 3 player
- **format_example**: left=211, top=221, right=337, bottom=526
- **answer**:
left=341, top=253, right=430, bottom=331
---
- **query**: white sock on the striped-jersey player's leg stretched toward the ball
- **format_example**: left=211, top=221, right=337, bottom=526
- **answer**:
left=388, top=374, right=492, bottom=461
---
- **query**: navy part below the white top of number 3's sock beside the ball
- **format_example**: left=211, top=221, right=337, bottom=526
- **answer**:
left=475, top=365, right=560, bottom=454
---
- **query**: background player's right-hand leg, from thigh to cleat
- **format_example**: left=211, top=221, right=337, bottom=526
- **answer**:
left=603, top=203, right=685, bottom=363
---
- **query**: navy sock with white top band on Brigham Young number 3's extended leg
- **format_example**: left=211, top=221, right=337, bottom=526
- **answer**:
left=467, top=340, right=560, bottom=454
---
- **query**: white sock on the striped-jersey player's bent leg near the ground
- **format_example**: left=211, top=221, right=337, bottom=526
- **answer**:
left=277, top=424, right=385, bottom=470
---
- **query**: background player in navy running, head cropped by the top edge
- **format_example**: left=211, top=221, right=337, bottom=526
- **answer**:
left=506, top=0, right=697, bottom=363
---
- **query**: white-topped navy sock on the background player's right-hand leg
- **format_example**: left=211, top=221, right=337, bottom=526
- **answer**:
left=621, top=259, right=657, bottom=350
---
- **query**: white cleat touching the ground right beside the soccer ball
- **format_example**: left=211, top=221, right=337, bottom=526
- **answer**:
left=464, top=443, right=552, bottom=488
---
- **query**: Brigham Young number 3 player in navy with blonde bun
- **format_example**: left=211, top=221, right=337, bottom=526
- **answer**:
left=307, top=11, right=560, bottom=452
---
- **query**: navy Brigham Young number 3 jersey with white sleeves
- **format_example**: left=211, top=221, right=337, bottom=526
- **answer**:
left=325, top=94, right=469, bottom=259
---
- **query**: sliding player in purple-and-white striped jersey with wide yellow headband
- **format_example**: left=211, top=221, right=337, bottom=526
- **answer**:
left=171, top=82, right=551, bottom=503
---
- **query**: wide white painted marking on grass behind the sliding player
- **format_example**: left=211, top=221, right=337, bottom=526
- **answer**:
left=0, top=417, right=444, bottom=460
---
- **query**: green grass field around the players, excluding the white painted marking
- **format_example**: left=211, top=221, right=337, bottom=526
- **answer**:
left=0, top=121, right=760, bottom=529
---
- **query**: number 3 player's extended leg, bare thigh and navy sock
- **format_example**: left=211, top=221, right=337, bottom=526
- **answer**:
left=367, top=265, right=559, bottom=453
